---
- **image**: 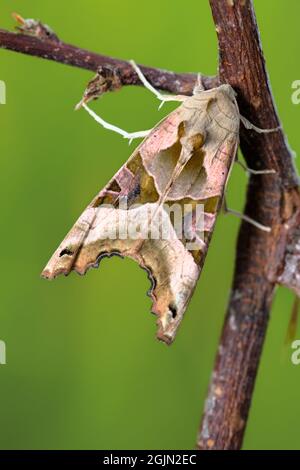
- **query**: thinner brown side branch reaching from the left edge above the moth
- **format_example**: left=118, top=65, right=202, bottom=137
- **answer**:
left=0, top=29, right=218, bottom=95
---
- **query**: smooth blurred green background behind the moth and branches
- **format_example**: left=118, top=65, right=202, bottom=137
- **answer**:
left=0, top=0, right=300, bottom=449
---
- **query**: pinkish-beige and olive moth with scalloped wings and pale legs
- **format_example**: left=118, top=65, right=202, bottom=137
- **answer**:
left=42, top=62, right=273, bottom=344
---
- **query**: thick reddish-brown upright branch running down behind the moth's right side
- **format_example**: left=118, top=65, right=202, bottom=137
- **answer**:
left=197, top=0, right=300, bottom=450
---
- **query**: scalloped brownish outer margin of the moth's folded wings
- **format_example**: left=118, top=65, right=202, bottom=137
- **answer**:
left=41, top=237, right=198, bottom=345
